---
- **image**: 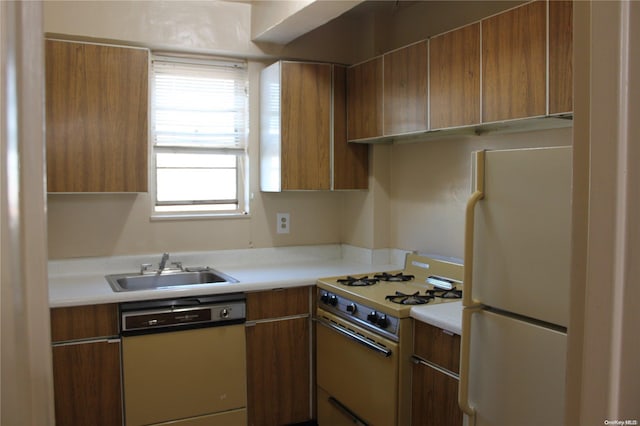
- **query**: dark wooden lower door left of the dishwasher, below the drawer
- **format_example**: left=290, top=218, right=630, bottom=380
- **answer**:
left=53, top=340, right=122, bottom=426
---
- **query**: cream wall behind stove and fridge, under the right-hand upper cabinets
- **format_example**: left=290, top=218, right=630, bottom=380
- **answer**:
left=390, top=128, right=572, bottom=258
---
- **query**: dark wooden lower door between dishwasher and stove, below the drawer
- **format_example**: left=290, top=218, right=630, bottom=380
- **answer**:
left=246, top=317, right=311, bottom=426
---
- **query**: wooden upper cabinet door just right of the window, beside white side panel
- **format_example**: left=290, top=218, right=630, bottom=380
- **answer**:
left=281, top=62, right=331, bottom=190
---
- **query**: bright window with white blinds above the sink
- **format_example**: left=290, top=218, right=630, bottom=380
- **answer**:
left=151, top=56, right=248, bottom=217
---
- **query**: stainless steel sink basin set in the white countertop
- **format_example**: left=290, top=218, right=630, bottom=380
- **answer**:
left=105, top=268, right=238, bottom=291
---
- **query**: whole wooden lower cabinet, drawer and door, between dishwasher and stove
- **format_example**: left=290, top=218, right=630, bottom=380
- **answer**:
left=246, top=287, right=312, bottom=426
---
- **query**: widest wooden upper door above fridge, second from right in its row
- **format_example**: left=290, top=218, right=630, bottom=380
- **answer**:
left=482, top=1, right=547, bottom=123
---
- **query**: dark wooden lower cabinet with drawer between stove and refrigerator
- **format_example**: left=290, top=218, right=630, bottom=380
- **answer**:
left=411, top=321, right=462, bottom=426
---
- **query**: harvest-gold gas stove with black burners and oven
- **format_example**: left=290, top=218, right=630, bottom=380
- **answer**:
left=316, top=254, right=463, bottom=426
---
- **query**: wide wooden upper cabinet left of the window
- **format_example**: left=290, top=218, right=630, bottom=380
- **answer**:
left=45, top=40, right=149, bottom=192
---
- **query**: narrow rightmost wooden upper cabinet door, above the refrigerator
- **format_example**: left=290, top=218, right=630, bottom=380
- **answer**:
left=549, top=0, right=573, bottom=114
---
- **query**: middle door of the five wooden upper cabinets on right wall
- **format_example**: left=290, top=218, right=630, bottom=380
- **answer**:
left=429, top=23, right=480, bottom=129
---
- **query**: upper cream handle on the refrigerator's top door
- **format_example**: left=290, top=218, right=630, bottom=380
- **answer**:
left=462, top=151, right=484, bottom=307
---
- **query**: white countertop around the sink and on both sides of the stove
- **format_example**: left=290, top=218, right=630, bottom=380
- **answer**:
left=49, top=245, right=462, bottom=334
